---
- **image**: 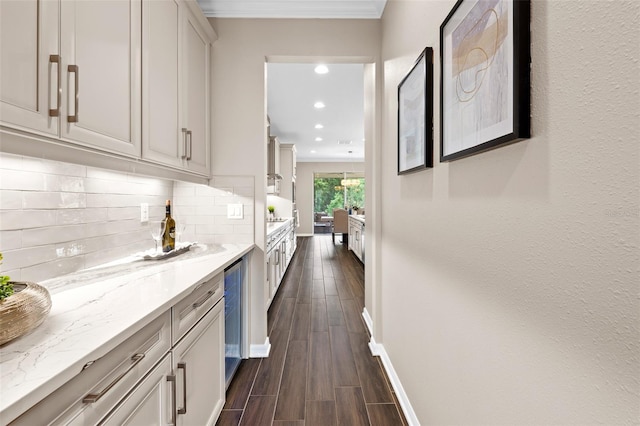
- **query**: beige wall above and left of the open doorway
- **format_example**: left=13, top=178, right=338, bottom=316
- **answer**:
left=209, top=19, right=380, bottom=345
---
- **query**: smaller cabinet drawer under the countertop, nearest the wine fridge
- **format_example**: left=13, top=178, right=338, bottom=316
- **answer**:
left=171, top=274, right=224, bottom=345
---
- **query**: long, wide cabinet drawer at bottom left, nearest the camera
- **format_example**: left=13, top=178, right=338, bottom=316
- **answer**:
left=11, top=311, right=171, bottom=426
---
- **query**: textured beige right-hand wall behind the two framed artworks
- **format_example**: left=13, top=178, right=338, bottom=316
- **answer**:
left=380, top=0, right=640, bottom=425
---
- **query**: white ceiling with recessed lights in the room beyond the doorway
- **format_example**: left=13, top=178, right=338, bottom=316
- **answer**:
left=267, top=63, right=364, bottom=162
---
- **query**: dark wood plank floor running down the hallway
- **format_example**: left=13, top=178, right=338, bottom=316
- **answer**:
left=217, top=234, right=407, bottom=426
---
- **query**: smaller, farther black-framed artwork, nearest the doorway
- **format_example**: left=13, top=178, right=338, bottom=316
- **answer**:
left=398, top=47, right=433, bottom=175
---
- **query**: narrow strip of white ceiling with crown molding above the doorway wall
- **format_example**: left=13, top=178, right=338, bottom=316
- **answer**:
left=198, top=0, right=386, bottom=19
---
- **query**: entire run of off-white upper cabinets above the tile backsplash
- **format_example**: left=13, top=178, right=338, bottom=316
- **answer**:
left=0, top=0, right=216, bottom=176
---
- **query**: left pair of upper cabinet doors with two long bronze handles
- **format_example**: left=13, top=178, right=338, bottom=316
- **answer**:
left=0, top=0, right=142, bottom=157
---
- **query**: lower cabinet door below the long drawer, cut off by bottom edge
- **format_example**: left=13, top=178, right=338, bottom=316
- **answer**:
left=100, top=354, right=175, bottom=426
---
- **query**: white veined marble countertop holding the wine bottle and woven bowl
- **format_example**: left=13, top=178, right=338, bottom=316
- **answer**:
left=0, top=244, right=253, bottom=424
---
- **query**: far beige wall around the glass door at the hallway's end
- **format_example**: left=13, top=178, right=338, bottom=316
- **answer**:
left=296, top=163, right=364, bottom=235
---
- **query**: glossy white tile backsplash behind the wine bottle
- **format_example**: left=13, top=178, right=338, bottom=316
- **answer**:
left=0, top=153, right=254, bottom=281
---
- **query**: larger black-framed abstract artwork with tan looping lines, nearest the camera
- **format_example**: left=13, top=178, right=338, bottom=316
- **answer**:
left=440, top=0, right=531, bottom=161
